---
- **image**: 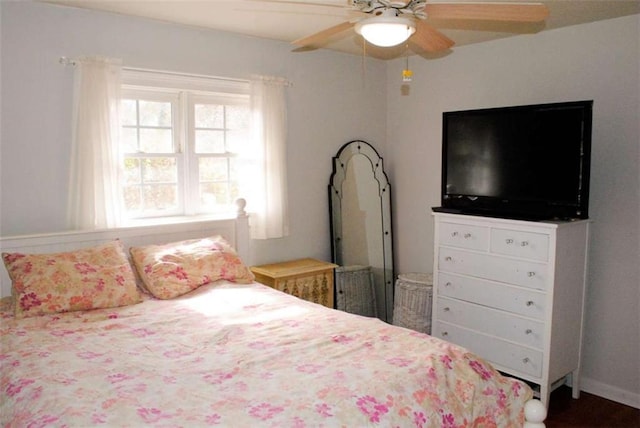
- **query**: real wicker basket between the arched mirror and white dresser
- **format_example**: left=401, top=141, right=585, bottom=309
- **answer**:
left=393, top=273, right=433, bottom=334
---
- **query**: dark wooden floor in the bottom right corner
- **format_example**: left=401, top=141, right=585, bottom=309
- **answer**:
left=545, top=386, right=640, bottom=428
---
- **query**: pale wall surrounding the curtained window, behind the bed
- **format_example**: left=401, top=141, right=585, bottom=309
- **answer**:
left=0, top=2, right=386, bottom=263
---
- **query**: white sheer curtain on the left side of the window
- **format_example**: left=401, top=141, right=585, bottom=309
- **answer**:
left=68, top=57, right=122, bottom=229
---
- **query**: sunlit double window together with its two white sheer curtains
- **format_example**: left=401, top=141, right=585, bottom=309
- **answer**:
left=68, top=61, right=289, bottom=239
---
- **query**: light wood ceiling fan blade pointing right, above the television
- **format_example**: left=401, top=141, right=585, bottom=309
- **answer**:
left=424, top=3, right=549, bottom=22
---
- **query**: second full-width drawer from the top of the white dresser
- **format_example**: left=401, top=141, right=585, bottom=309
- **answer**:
left=438, top=273, right=546, bottom=320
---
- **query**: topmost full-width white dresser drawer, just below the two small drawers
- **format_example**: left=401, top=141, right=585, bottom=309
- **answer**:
left=438, top=247, right=548, bottom=290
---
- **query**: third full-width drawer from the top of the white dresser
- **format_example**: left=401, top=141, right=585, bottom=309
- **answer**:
left=436, top=297, right=544, bottom=350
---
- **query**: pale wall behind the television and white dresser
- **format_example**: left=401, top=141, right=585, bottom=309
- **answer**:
left=385, top=15, right=640, bottom=407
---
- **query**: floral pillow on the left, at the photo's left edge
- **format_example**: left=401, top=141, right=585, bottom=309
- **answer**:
left=2, top=240, right=141, bottom=318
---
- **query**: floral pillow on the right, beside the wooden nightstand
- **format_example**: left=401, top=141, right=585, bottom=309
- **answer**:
left=130, top=236, right=255, bottom=299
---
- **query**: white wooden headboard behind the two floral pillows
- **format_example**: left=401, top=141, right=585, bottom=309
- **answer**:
left=0, top=210, right=250, bottom=297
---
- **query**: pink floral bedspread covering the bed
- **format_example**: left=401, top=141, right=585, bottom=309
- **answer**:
left=0, top=282, right=532, bottom=427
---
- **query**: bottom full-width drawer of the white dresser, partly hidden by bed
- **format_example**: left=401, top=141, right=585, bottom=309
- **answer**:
left=433, top=321, right=542, bottom=378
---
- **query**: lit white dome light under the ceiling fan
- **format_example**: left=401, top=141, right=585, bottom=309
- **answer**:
left=355, top=15, right=416, bottom=47
